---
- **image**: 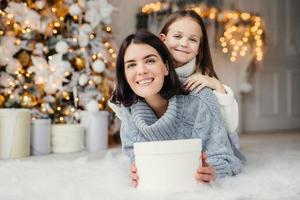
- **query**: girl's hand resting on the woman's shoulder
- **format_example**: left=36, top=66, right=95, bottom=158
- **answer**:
left=184, top=72, right=226, bottom=94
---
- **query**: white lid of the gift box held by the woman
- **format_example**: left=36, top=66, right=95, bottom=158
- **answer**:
left=133, top=139, right=202, bottom=155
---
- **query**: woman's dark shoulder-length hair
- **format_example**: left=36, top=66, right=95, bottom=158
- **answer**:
left=111, top=30, right=186, bottom=106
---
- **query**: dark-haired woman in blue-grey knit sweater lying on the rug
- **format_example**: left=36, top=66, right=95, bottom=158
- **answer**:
left=112, top=31, right=242, bottom=186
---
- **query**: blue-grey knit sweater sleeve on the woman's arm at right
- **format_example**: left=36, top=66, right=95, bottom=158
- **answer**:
left=195, top=89, right=242, bottom=177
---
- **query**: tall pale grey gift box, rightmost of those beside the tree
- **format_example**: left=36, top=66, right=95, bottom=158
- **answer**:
left=80, top=111, right=108, bottom=152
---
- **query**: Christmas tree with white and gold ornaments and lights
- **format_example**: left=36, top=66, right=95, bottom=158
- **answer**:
left=0, top=0, right=116, bottom=123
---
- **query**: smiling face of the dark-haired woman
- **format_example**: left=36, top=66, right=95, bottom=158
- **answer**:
left=124, top=43, right=168, bottom=98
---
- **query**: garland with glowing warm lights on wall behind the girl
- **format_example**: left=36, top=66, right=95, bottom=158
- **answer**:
left=136, top=1, right=265, bottom=62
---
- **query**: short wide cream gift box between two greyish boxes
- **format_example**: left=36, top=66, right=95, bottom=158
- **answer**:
left=51, top=124, right=84, bottom=153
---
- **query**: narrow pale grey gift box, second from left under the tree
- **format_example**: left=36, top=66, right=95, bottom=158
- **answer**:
left=30, top=119, right=51, bottom=155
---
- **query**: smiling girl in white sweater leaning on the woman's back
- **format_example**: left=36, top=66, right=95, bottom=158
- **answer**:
left=160, top=10, right=239, bottom=148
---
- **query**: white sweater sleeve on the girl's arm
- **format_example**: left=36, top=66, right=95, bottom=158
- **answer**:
left=213, top=85, right=239, bottom=133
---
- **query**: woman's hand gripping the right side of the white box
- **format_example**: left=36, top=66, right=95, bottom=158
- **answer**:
left=196, top=153, right=215, bottom=183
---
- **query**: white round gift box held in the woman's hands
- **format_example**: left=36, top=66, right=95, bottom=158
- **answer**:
left=134, top=139, right=202, bottom=191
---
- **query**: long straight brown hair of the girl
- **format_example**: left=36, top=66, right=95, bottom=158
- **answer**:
left=160, top=10, right=218, bottom=79
